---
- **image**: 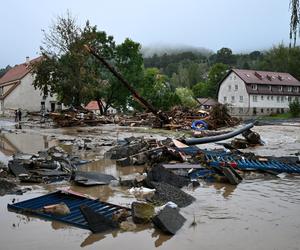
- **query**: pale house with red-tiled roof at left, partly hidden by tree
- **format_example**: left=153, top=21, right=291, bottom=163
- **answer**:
left=0, top=57, right=59, bottom=113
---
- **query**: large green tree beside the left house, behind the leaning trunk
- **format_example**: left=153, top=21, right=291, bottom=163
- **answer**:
left=34, top=14, right=143, bottom=113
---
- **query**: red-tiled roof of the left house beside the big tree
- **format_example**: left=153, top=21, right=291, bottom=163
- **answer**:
left=0, top=57, right=42, bottom=85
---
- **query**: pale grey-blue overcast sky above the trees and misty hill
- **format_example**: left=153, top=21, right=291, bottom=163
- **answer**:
left=0, top=0, right=290, bottom=68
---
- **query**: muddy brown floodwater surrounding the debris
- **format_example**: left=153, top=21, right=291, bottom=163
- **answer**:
left=0, top=125, right=300, bottom=250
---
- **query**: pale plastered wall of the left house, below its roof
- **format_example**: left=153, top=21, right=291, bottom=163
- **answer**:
left=3, top=74, right=56, bottom=112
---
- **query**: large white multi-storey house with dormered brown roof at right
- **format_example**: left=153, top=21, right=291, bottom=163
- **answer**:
left=218, top=69, right=300, bottom=116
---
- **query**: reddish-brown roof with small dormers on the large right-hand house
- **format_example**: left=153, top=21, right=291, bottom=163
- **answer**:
left=230, top=69, right=300, bottom=86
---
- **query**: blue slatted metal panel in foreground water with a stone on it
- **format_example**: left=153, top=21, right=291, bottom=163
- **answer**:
left=7, top=191, right=130, bottom=229
